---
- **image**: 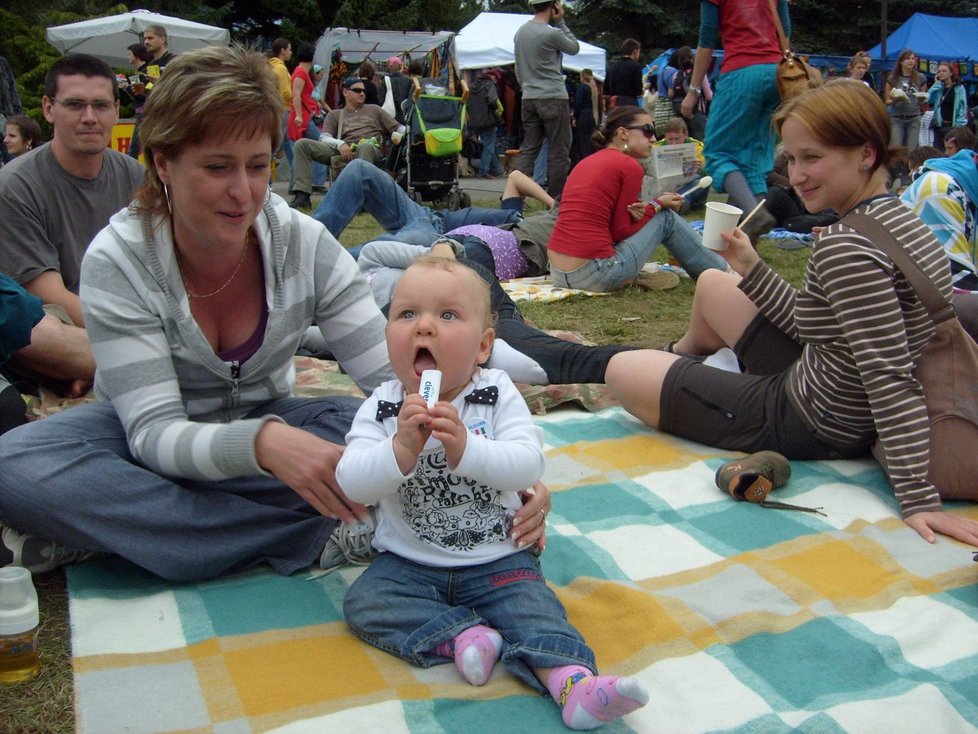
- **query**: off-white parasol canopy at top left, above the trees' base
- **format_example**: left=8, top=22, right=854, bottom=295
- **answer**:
left=47, top=10, right=231, bottom=67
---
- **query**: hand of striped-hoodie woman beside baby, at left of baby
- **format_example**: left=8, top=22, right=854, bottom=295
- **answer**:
left=255, top=421, right=368, bottom=522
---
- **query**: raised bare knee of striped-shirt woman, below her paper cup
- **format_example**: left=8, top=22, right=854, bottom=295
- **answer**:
left=674, top=270, right=757, bottom=354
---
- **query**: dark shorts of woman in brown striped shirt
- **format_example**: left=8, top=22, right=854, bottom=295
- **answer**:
left=659, top=316, right=870, bottom=460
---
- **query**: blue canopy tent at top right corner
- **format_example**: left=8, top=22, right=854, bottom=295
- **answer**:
left=869, top=13, right=978, bottom=80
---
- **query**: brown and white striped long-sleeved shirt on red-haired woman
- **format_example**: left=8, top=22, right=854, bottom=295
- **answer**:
left=740, top=197, right=951, bottom=517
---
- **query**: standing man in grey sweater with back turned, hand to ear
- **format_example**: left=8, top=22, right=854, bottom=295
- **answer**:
left=513, top=0, right=581, bottom=198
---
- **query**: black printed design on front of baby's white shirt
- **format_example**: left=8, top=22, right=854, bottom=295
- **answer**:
left=398, top=448, right=512, bottom=551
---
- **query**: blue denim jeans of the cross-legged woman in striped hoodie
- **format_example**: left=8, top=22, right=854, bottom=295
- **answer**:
left=0, top=397, right=362, bottom=581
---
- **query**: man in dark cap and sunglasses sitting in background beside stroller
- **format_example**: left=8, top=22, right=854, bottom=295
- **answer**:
left=290, top=78, right=404, bottom=209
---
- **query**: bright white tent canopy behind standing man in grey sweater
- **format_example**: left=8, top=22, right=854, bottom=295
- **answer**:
left=455, top=13, right=606, bottom=80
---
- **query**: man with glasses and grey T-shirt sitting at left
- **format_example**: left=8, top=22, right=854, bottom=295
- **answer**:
left=0, top=54, right=144, bottom=393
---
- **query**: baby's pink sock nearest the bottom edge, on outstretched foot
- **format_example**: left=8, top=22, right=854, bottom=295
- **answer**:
left=547, top=665, right=649, bottom=731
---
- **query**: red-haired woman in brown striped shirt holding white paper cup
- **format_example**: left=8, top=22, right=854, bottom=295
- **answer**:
left=606, top=79, right=978, bottom=546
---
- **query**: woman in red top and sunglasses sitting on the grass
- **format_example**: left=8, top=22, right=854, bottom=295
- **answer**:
left=547, top=107, right=727, bottom=293
